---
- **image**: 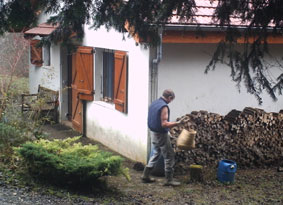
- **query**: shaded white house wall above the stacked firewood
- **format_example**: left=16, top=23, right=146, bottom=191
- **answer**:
left=158, top=44, right=283, bottom=120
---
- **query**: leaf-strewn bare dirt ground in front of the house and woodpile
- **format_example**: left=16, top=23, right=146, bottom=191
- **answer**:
left=40, top=125, right=283, bottom=205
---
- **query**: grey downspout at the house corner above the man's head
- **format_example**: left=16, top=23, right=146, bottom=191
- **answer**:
left=151, top=28, right=163, bottom=102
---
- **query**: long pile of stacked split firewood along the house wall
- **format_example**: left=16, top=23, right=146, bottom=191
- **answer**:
left=170, top=107, right=283, bottom=171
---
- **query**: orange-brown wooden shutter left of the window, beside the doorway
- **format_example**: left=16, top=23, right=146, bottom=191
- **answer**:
left=72, top=47, right=94, bottom=100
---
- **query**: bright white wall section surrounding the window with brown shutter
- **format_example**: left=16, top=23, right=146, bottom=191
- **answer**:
left=83, top=28, right=149, bottom=162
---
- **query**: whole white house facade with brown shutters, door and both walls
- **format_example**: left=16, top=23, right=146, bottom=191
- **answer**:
left=27, top=2, right=283, bottom=163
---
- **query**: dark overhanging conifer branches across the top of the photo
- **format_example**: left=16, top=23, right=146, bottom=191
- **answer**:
left=0, top=0, right=283, bottom=103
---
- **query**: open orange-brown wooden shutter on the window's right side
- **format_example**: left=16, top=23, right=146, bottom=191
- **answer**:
left=114, top=51, right=127, bottom=113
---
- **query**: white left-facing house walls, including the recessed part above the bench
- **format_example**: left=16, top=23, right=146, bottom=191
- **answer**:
left=29, top=15, right=150, bottom=162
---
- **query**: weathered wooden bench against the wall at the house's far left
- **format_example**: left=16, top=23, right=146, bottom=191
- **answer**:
left=21, top=85, right=59, bottom=122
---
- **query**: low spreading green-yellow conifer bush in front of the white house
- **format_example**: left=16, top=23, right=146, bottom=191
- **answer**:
left=16, top=137, right=129, bottom=187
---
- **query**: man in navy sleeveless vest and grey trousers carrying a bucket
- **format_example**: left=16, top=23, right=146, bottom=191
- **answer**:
left=142, top=89, right=180, bottom=186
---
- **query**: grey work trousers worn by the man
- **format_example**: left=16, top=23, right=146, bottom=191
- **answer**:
left=147, top=132, right=175, bottom=172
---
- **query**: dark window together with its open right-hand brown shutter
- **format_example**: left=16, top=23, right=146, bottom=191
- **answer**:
left=102, top=51, right=128, bottom=113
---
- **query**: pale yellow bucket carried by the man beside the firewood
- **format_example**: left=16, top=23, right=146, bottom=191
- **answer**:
left=177, top=129, right=197, bottom=150
